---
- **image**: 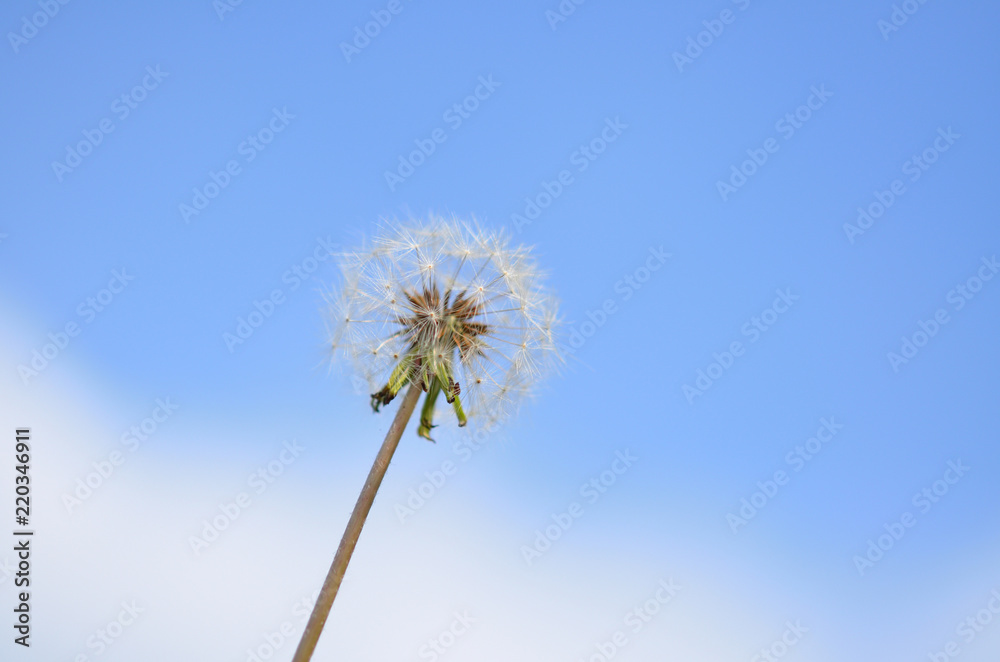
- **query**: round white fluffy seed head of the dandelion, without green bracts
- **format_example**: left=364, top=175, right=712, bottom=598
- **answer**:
left=328, top=217, right=561, bottom=424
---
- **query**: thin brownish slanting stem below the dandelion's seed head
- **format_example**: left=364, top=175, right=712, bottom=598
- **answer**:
left=292, top=383, right=421, bottom=662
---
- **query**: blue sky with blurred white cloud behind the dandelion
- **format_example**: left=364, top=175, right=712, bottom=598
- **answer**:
left=0, top=0, right=1000, bottom=661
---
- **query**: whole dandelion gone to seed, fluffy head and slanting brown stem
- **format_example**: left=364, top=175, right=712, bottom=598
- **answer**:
left=293, top=218, right=559, bottom=662
